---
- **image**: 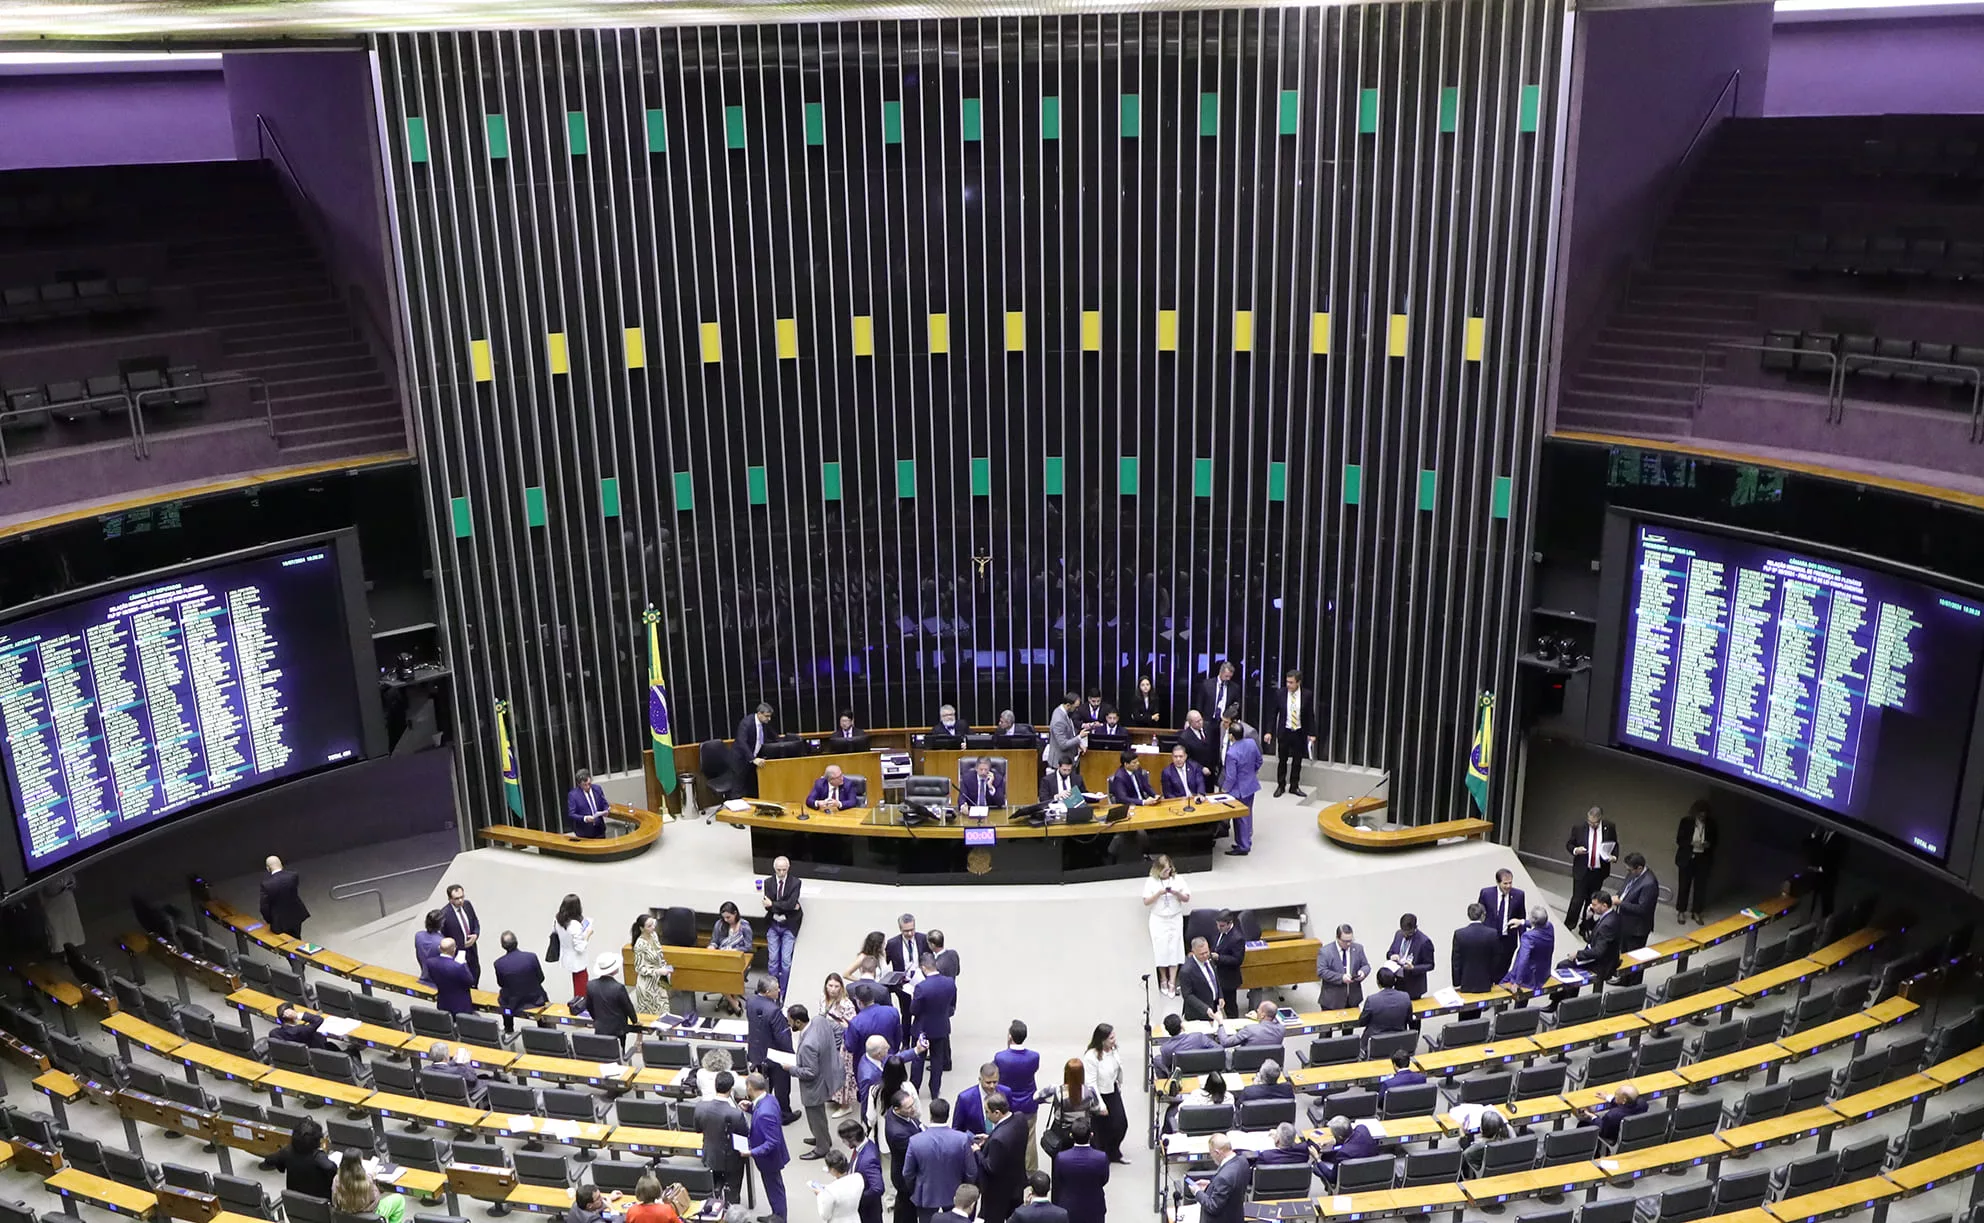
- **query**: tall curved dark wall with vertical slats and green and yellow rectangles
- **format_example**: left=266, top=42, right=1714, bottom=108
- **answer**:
left=375, top=0, right=1561, bottom=824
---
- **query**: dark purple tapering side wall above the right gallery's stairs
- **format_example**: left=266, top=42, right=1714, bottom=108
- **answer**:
left=1557, top=4, right=1772, bottom=381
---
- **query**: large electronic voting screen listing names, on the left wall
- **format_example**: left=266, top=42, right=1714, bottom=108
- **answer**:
left=0, top=540, right=365, bottom=876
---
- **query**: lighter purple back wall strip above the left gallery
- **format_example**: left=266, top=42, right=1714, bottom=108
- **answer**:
left=0, top=64, right=234, bottom=171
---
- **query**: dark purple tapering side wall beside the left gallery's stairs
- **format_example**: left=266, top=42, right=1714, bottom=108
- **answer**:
left=220, top=52, right=395, bottom=373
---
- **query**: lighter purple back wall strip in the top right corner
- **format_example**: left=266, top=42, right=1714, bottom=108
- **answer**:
left=1764, top=14, right=1984, bottom=115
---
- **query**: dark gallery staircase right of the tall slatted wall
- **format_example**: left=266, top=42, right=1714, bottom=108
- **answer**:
left=1555, top=117, right=1952, bottom=437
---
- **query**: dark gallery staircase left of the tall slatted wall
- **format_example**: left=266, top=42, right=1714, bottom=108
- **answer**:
left=171, top=161, right=407, bottom=465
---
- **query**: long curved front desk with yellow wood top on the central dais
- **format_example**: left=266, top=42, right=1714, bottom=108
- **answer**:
left=714, top=796, right=1246, bottom=883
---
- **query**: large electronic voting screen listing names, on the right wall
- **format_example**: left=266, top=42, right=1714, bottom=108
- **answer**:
left=1613, top=522, right=1984, bottom=858
